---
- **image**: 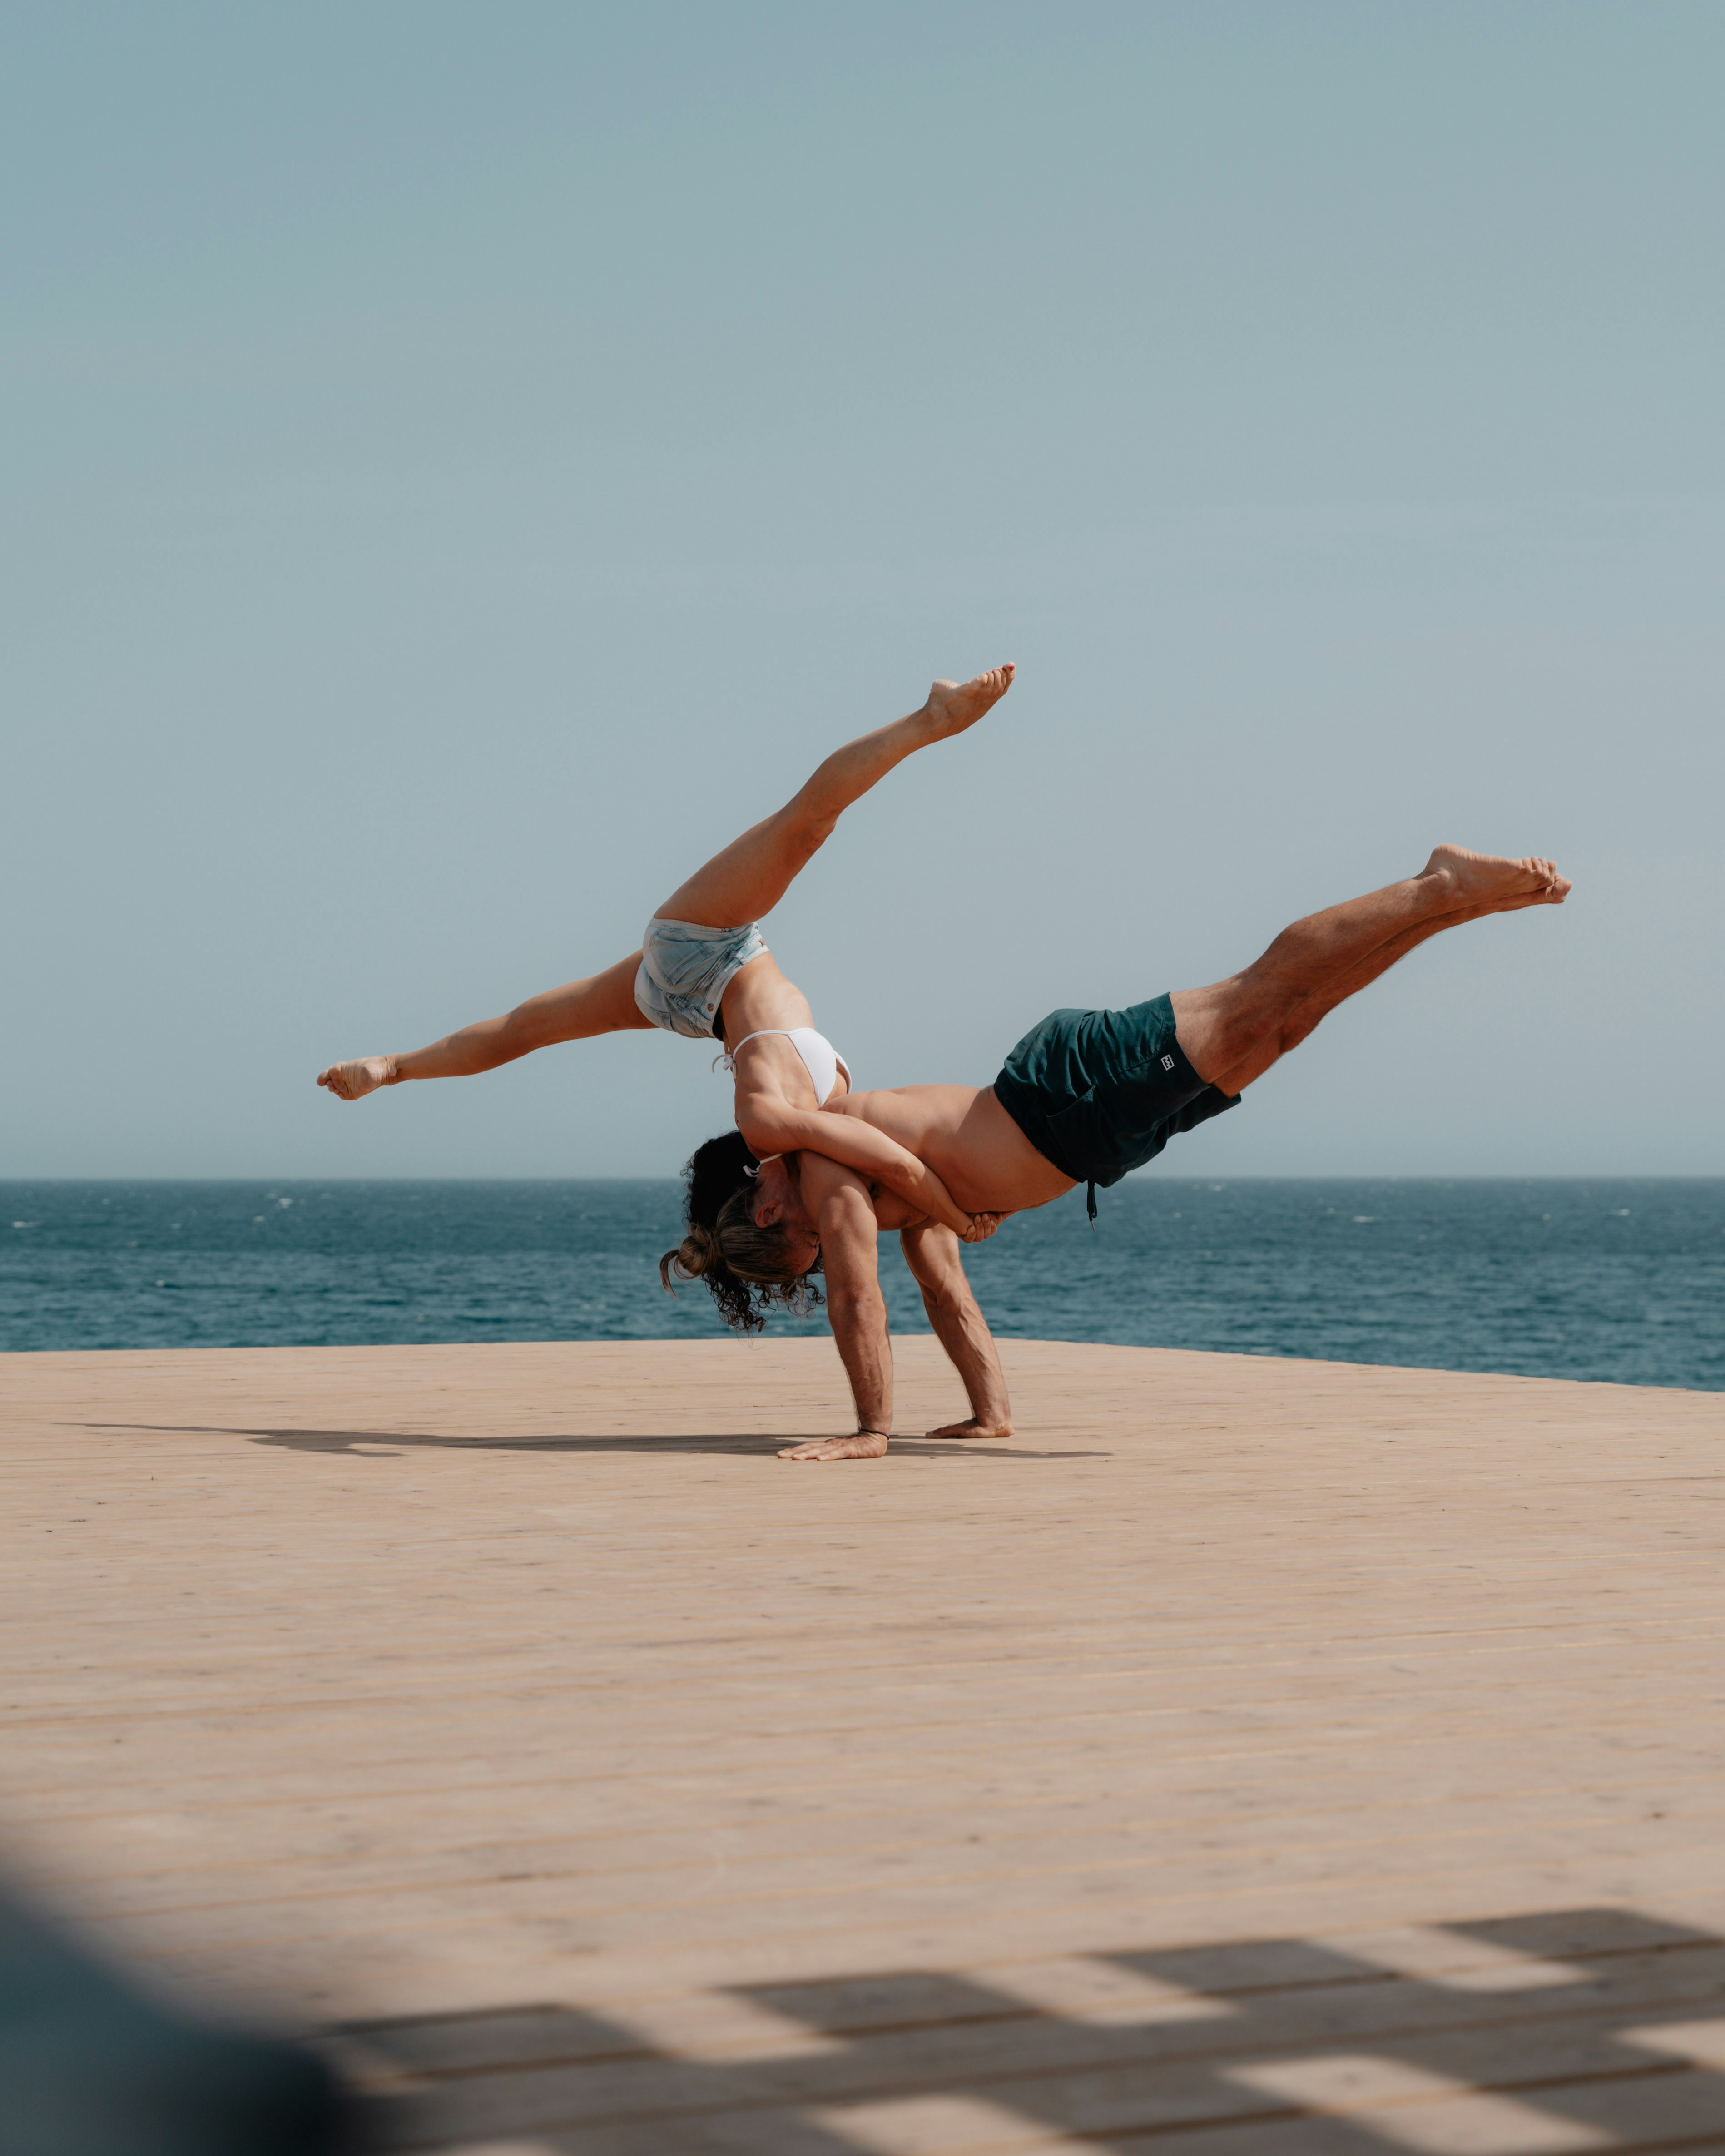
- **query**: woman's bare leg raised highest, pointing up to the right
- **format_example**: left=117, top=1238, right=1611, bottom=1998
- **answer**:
left=660, top=666, right=1013, bottom=929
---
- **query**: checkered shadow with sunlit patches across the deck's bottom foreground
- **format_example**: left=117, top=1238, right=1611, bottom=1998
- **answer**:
left=341, top=1908, right=1725, bottom=2156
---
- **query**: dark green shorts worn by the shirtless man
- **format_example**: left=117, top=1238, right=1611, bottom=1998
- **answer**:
left=994, top=996, right=1240, bottom=1216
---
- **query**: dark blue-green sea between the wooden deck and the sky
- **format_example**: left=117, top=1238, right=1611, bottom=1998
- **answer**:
left=0, top=1175, right=1725, bottom=1391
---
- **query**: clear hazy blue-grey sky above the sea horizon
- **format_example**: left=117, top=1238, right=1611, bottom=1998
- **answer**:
left=0, top=0, right=1725, bottom=1175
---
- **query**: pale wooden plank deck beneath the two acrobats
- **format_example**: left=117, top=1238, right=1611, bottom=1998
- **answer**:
left=0, top=1341, right=1725, bottom=2156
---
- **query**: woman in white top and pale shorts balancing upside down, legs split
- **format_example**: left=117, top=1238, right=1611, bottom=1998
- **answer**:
left=317, top=666, right=1013, bottom=1328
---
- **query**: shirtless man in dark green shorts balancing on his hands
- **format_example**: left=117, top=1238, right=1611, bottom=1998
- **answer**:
left=755, top=845, right=1570, bottom=1460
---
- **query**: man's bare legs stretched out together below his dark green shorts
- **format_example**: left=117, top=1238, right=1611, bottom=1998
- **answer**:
left=1171, top=845, right=1570, bottom=1093
